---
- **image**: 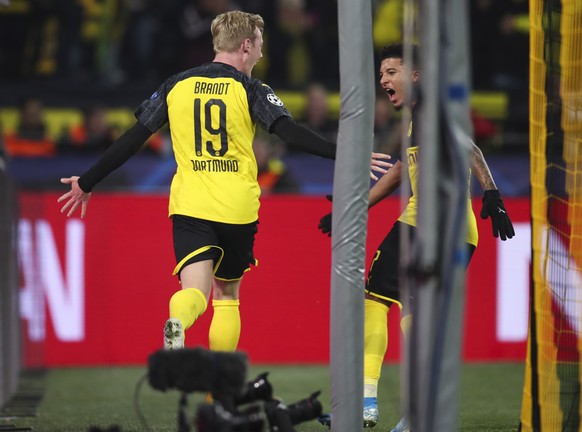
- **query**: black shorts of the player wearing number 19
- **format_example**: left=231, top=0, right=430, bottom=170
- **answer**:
left=172, top=215, right=259, bottom=280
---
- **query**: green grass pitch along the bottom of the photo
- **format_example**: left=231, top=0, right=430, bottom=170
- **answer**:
left=0, top=363, right=524, bottom=432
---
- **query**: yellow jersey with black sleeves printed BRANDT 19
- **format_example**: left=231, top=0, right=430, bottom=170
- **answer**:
left=136, top=62, right=290, bottom=224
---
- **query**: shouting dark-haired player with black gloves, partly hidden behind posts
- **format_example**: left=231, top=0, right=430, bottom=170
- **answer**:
left=319, top=44, right=515, bottom=432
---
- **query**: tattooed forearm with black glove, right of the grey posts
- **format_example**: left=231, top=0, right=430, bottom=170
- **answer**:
left=471, top=143, right=515, bottom=240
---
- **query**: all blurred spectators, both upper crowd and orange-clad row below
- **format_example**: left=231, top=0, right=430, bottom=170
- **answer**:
left=0, top=0, right=529, bottom=191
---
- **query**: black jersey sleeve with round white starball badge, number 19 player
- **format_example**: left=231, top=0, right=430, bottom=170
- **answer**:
left=249, top=80, right=291, bottom=132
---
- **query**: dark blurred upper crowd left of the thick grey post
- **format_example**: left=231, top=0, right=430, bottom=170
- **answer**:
left=0, top=0, right=339, bottom=87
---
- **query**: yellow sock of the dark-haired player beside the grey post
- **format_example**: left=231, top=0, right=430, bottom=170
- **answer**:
left=364, top=299, right=388, bottom=397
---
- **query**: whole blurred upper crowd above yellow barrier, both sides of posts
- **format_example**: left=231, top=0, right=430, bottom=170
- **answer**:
left=0, top=0, right=528, bottom=90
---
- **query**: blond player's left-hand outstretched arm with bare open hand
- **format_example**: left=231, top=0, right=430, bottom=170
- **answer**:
left=57, top=122, right=152, bottom=217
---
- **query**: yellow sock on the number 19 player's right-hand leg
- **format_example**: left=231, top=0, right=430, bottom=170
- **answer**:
left=208, top=300, right=240, bottom=351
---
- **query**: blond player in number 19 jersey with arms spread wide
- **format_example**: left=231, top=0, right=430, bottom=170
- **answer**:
left=59, top=11, right=390, bottom=351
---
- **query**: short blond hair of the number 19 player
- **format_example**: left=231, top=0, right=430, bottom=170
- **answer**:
left=210, top=11, right=265, bottom=53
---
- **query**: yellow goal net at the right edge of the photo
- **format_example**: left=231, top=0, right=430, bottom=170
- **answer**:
left=520, top=0, right=582, bottom=431
